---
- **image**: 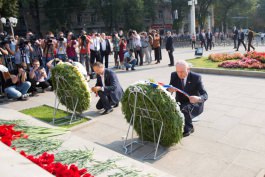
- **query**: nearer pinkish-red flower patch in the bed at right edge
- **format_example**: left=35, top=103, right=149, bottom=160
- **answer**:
left=218, top=58, right=265, bottom=69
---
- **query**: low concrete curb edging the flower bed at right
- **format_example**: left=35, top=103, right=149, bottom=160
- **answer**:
left=191, top=68, right=265, bottom=78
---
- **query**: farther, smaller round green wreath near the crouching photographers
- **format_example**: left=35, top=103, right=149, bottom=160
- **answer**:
left=51, top=63, right=91, bottom=113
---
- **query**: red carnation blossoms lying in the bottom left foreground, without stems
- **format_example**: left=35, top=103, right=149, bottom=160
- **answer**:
left=0, top=125, right=92, bottom=177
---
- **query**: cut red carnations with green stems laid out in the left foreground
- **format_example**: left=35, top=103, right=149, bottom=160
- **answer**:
left=0, top=119, right=154, bottom=177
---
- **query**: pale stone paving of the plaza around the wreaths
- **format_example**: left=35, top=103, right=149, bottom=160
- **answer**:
left=1, top=48, right=265, bottom=177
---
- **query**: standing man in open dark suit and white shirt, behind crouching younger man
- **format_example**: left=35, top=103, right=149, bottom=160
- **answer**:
left=100, top=33, right=111, bottom=68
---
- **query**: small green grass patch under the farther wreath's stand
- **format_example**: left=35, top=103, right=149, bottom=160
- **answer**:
left=20, top=105, right=88, bottom=128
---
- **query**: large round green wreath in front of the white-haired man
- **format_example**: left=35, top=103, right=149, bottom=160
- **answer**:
left=121, top=82, right=184, bottom=147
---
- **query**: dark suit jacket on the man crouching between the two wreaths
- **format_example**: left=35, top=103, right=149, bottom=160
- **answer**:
left=96, top=68, right=123, bottom=104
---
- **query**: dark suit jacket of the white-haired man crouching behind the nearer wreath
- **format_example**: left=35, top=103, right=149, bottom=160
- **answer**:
left=170, top=72, right=208, bottom=117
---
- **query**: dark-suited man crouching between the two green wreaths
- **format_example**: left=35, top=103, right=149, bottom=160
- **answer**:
left=92, top=62, right=123, bottom=115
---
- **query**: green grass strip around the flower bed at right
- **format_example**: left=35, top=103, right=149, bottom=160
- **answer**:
left=187, top=57, right=265, bottom=72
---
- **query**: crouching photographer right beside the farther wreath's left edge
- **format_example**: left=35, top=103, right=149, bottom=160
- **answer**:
left=29, top=60, right=50, bottom=92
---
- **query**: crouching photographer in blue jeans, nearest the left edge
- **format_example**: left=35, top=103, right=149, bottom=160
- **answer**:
left=5, top=65, right=31, bottom=100
